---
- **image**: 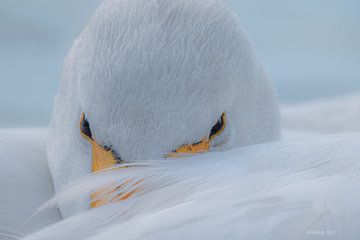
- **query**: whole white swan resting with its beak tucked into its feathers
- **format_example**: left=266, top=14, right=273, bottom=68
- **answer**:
left=0, top=0, right=360, bottom=240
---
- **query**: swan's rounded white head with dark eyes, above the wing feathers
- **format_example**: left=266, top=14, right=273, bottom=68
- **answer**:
left=48, top=0, right=280, bottom=215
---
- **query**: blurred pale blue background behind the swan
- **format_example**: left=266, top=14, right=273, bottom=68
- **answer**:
left=0, top=0, right=360, bottom=127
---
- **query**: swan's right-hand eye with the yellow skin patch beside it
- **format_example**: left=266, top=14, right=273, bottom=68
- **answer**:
left=166, top=113, right=226, bottom=158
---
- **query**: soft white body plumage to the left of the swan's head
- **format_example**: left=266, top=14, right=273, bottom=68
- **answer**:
left=0, top=129, right=61, bottom=236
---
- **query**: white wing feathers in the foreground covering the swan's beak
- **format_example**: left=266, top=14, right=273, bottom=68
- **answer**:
left=22, top=134, right=360, bottom=240
